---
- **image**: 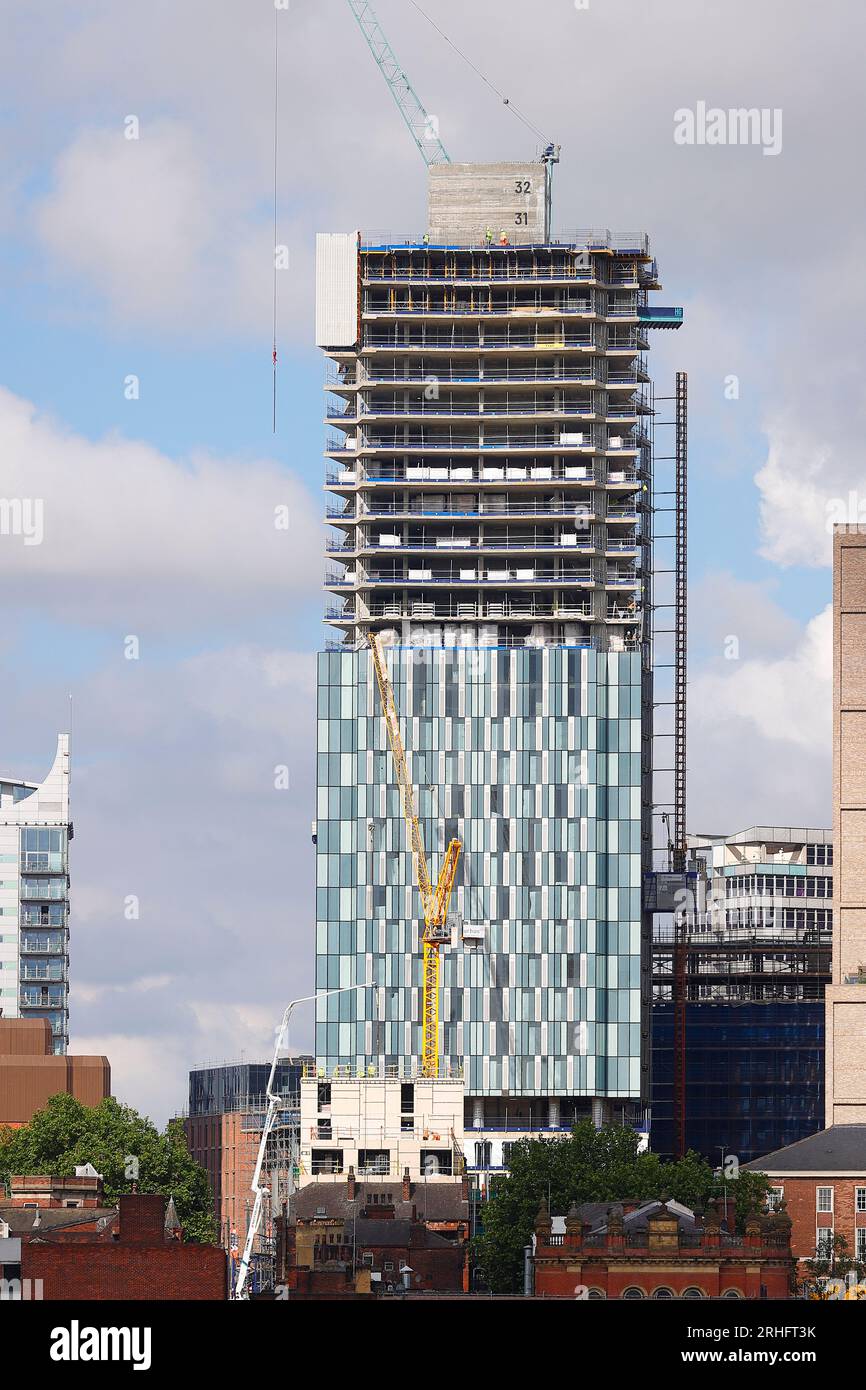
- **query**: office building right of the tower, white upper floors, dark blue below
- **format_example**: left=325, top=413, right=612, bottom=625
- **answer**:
left=651, top=826, right=833, bottom=1163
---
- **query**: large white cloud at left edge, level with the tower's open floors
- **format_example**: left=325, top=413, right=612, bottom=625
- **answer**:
left=0, top=388, right=321, bottom=632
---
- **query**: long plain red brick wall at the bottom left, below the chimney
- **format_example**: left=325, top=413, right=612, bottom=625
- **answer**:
left=21, top=1241, right=227, bottom=1302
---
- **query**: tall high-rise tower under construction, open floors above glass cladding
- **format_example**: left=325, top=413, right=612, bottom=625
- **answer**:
left=316, top=161, right=681, bottom=1129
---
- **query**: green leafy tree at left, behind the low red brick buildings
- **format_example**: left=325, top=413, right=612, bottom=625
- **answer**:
left=0, top=1095, right=215, bottom=1241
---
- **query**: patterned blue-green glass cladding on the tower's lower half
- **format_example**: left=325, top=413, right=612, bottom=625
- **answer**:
left=317, top=648, right=641, bottom=1098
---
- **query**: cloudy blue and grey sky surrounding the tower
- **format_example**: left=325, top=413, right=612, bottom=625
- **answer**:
left=0, top=0, right=866, bottom=1123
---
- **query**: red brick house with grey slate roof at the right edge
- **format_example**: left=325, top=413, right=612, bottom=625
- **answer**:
left=745, top=1125, right=866, bottom=1262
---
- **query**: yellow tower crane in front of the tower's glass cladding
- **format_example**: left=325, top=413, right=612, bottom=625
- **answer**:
left=367, top=632, right=463, bottom=1076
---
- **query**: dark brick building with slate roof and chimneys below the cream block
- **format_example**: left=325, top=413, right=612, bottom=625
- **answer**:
left=277, top=1170, right=468, bottom=1298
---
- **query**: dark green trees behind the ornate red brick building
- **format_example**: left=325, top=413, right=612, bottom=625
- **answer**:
left=474, top=1120, right=769, bottom=1293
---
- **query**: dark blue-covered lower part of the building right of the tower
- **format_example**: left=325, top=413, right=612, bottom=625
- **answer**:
left=651, top=1001, right=824, bottom=1163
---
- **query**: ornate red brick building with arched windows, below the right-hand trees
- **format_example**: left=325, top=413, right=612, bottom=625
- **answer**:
left=532, top=1201, right=795, bottom=1298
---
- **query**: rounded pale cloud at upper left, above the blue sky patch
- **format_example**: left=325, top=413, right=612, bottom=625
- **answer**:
left=33, top=118, right=313, bottom=338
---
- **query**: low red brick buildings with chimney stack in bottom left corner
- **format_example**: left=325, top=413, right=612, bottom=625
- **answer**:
left=0, top=1177, right=227, bottom=1301
